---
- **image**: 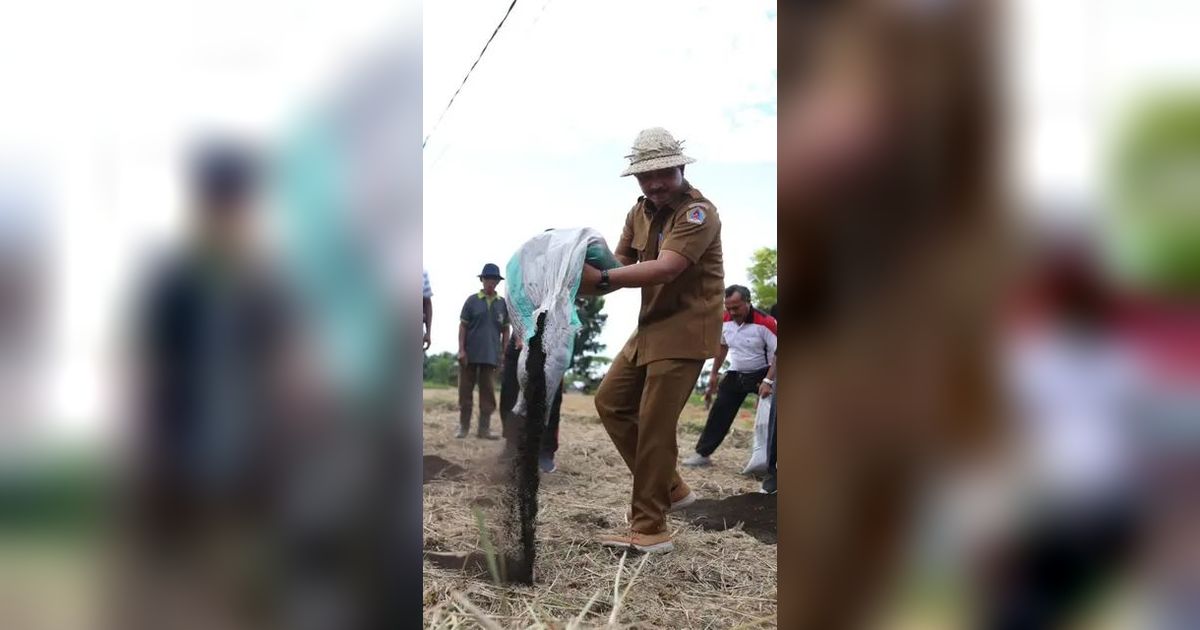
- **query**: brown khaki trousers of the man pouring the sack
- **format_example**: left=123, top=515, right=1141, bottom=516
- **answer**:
left=595, top=353, right=704, bottom=534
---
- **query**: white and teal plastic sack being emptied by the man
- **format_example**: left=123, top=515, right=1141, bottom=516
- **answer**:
left=505, top=228, right=617, bottom=415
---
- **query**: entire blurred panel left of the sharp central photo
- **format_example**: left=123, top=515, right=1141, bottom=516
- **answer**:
left=0, top=0, right=421, bottom=629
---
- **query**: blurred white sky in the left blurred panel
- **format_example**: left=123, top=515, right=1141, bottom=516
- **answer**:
left=0, top=0, right=418, bottom=439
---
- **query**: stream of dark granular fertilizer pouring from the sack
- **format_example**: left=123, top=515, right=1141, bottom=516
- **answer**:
left=500, top=313, right=546, bottom=584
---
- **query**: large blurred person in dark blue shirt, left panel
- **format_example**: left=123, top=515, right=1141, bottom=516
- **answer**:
left=118, top=140, right=294, bottom=628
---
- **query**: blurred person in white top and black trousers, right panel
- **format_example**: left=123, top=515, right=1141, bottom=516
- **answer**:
left=980, top=234, right=1141, bottom=630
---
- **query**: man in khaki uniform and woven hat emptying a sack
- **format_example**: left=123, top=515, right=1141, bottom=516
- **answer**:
left=581, top=127, right=725, bottom=552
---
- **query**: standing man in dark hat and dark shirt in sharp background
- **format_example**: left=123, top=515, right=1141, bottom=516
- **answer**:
left=455, top=263, right=510, bottom=439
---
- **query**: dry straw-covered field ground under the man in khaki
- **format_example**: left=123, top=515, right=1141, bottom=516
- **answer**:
left=425, top=390, right=775, bottom=628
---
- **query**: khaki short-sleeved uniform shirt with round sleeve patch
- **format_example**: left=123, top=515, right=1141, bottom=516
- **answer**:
left=614, top=181, right=725, bottom=366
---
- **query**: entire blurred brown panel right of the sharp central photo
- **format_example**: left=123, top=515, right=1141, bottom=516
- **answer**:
left=779, top=0, right=1200, bottom=628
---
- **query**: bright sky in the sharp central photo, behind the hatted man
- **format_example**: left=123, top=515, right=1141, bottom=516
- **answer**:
left=424, top=0, right=776, bottom=356
